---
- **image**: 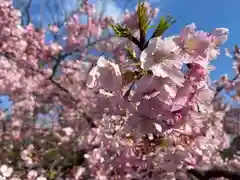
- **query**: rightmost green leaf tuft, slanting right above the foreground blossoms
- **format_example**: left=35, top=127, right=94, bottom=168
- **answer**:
left=152, top=15, right=176, bottom=38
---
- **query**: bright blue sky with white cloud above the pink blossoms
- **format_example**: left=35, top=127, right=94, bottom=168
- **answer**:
left=3, top=0, right=240, bottom=106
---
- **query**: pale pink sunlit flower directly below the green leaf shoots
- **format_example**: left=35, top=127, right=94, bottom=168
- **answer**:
left=140, top=37, right=184, bottom=85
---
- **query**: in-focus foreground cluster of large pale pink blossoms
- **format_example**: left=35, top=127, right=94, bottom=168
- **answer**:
left=87, top=24, right=228, bottom=133
